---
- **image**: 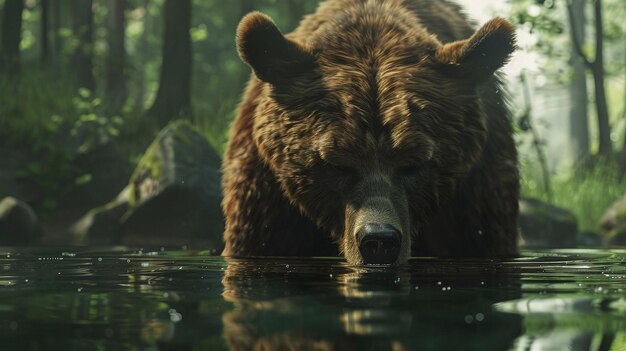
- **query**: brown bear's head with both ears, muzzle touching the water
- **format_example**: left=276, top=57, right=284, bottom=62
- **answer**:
left=237, top=8, right=515, bottom=264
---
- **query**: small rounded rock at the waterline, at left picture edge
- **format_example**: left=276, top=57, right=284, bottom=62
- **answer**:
left=0, top=196, right=42, bottom=245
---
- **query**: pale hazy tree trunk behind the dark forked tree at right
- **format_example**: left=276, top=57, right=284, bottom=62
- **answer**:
left=569, top=0, right=589, bottom=164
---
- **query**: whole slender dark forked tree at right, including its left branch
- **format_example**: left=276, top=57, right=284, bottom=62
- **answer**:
left=567, top=0, right=613, bottom=155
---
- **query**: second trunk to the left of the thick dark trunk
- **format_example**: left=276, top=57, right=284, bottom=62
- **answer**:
left=73, top=0, right=96, bottom=91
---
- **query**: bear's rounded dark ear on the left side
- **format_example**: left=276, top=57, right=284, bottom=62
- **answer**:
left=237, top=12, right=313, bottom=84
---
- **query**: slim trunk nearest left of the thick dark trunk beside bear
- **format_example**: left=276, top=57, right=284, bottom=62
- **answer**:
left=106, top=0, right=127, bottom=113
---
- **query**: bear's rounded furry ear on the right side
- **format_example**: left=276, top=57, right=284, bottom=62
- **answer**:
left=434, top=18, right=515, bottom=82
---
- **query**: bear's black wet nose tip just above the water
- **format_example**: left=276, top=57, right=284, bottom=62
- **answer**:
left=356, top=223, right=400, bottom=264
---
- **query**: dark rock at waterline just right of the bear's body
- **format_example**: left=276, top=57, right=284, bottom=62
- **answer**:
left=519, top=199, right=578, bottom=248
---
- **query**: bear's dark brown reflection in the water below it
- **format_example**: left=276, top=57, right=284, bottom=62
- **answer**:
left=222, top=259, right=521, bottom=350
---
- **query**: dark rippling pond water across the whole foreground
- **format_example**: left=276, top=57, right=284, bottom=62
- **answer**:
left=0, top=248, right=626, bottom=351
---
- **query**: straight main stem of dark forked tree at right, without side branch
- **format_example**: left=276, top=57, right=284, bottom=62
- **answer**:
left=592, top=0, right=613, bottom=155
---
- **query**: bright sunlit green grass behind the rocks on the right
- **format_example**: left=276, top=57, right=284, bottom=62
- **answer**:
left=521, top=163, right=626, bottom=230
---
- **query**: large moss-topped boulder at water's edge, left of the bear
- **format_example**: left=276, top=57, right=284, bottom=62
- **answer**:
left=72, top=122, right=224, bottom=250
